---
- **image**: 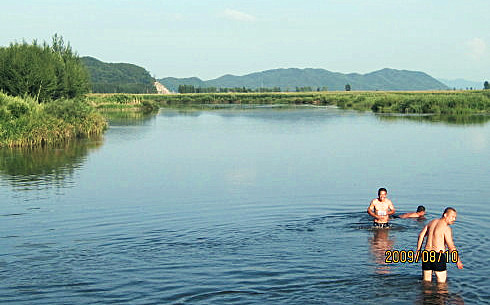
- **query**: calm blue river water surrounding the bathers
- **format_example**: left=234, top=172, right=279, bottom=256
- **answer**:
left=0, top=107, right=490, bottom=304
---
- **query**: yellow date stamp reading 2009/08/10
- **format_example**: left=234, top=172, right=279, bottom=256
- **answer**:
left=385, top=250, right=458, bottom=264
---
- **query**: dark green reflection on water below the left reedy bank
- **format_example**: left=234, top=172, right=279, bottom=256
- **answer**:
left=0, top=137, right=102, bottom=190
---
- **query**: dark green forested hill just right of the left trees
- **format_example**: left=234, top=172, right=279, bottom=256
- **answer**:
left=81, top=56, right=156, bottom=93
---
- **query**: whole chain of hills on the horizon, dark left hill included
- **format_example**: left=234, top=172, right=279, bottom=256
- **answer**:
left=81, top=56, right=474, bottom=93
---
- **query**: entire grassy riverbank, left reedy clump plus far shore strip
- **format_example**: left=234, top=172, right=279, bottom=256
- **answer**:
left=0, top=90, right=490, bottom=147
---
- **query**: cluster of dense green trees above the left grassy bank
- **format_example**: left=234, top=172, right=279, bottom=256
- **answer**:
left=0, top=34, right=90, bottom=103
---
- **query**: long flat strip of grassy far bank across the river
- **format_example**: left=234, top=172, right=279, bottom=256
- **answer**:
left=91, top=90, right=490, bottom=115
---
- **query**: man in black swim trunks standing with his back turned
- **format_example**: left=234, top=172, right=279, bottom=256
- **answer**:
left=417, top=207, right=463, bottom=283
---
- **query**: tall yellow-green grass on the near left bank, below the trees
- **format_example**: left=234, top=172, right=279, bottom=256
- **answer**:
left=0, top=92, right=107, bottom=147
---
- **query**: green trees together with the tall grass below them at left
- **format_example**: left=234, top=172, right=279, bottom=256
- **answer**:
left=0, top=35, right=107, bottom=147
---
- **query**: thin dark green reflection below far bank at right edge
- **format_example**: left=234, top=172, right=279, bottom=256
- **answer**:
left=377, top=114, right=490, bottom=125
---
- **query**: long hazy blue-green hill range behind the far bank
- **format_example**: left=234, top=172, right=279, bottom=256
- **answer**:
left=159, top=68, right=449, bottom=91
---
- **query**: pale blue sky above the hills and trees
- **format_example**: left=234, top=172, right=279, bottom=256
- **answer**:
left=0, top=0, right=490, bottom=82
